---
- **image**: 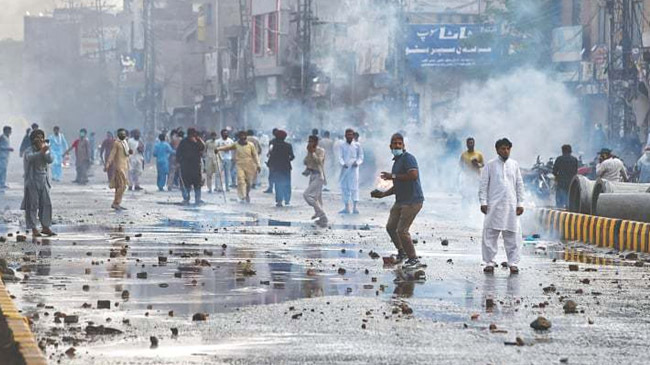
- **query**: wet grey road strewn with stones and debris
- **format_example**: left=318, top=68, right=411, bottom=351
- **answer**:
left=0, top=173, right=650, bottom=364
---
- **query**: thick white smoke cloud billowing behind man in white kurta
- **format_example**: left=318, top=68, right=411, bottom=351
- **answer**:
left=444, top=68, right=583, bottom=164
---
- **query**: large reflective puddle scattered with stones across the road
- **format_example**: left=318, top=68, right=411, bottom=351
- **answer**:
left=6, top=219, right=460, bottom=318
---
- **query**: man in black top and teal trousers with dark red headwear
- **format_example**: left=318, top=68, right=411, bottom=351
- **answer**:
left=269, top=130, right=295, bottom=207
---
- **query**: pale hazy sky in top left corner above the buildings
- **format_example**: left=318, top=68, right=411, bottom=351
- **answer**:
left=0, top=0, right=122, bottom=39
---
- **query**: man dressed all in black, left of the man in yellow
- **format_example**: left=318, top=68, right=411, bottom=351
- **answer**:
left=176, top=128, right=205, bottom=205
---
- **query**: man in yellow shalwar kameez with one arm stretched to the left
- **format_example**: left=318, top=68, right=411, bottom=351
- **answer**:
left=215, top=131, right=262, bottom=203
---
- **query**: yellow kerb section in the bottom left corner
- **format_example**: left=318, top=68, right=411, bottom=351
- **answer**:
left=0, top=280, right=47, bottom=365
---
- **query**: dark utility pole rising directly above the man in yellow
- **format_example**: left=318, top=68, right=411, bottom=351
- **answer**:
left=239, top=0, right=256, bottom=129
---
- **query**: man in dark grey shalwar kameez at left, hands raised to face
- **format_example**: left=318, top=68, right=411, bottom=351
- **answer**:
left=20, top=129, right=55, bottom=237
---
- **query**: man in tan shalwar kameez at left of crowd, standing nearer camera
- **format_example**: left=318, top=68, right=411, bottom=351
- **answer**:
left=104, top=128, right=133, bottom=210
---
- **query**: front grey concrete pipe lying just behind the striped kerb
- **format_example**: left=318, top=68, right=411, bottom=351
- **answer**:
left=596, top=193, right=650, bottom=223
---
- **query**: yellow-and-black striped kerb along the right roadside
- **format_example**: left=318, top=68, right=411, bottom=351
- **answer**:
left=536, top=209, right=650, bottom=253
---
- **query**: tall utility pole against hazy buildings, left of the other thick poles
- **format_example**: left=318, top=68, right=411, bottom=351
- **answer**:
left=143, top=0, right=156, bottom=134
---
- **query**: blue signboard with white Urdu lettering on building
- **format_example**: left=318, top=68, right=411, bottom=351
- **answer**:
left=405, top=24, right=497, bottom=68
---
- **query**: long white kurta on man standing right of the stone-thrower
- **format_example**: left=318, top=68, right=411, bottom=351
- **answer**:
left=479, top=157, right=524, bottom=232
